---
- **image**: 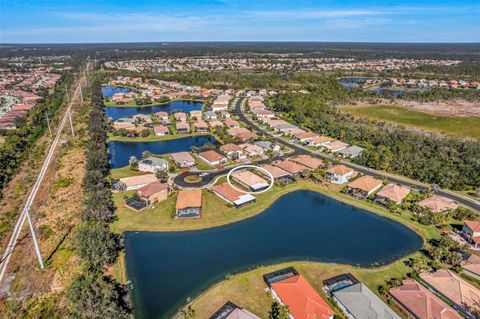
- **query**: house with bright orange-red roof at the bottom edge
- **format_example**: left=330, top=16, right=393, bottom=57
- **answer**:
left=271, top=275, right=335, bottom=319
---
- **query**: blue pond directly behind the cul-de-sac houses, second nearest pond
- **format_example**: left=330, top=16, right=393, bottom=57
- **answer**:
left=108, top=135, right=215, bottom=168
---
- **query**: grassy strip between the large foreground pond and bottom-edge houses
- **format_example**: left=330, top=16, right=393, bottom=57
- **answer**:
left=191, top=259, right=416, bottom=318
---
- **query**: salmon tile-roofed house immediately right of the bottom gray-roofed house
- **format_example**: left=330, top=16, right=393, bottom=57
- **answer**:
left=390, top=278, right=462, bottom=319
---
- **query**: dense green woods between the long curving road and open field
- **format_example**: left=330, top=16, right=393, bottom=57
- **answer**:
left=271, top=91, right=480, bottom=190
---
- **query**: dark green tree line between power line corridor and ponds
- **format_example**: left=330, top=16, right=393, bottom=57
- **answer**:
left=67, top=81, right=133, bottom=319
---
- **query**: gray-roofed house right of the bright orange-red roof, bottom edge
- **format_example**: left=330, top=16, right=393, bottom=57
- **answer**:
left=332, top=283, right=400, bottom=319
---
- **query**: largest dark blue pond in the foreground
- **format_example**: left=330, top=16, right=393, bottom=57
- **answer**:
left=125, top=191, right=422, bottom=319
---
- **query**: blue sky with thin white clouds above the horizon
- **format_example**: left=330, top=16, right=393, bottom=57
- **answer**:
left=0, top=0, right=480, bottom=43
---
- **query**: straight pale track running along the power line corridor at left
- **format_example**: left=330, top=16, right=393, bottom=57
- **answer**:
left=0, top=63, right=89, bottom=283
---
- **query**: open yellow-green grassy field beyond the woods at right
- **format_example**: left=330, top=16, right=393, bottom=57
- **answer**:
left=340, top=105, right=480, bottom=139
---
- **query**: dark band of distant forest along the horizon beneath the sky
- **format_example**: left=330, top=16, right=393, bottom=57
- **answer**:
left=0, top=42, right=480, bottom=60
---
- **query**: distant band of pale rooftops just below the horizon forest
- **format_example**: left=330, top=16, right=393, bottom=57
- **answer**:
left=105, top=55, right=460, bottom=72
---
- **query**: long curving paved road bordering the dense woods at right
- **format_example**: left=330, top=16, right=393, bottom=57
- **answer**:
left=235, top=98, right=480, bottom=211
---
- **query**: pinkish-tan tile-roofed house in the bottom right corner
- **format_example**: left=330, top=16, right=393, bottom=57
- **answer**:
left=420, top=269, right=480, bottom=317
